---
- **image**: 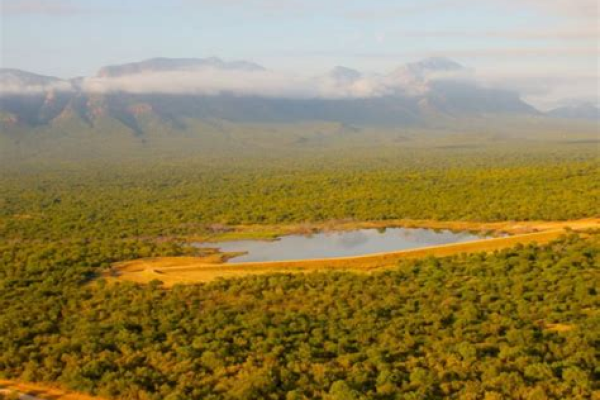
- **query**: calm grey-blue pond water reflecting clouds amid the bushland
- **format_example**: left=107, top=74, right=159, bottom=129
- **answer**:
left=198, top=228, right=482, bottom=263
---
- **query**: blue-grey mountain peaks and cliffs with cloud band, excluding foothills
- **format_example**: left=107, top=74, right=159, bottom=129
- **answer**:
left=0, top=58, right=598, bottom=133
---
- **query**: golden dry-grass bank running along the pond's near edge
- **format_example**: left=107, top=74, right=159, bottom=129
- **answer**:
left=109, top=219, right=600, bottom=287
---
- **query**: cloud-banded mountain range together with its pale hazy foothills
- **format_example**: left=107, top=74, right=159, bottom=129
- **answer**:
left=0, top=58, right=599, bottom=159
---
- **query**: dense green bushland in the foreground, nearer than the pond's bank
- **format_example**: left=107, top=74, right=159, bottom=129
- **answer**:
left=0, top=236, right=600, bottom=400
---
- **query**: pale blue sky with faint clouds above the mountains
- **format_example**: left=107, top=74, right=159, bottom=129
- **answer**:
left=0, top=0, right=600, bottom=109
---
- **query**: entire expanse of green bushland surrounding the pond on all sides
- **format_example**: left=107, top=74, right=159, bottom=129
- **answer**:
left=0, top=149, right=600, bottom=400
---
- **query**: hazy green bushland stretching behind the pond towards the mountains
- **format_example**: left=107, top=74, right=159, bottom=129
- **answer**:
left=0, top=150, right=600, bottom=240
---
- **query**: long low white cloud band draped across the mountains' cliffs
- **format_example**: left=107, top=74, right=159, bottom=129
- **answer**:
left=82, top=64, right=482, bottom=99
